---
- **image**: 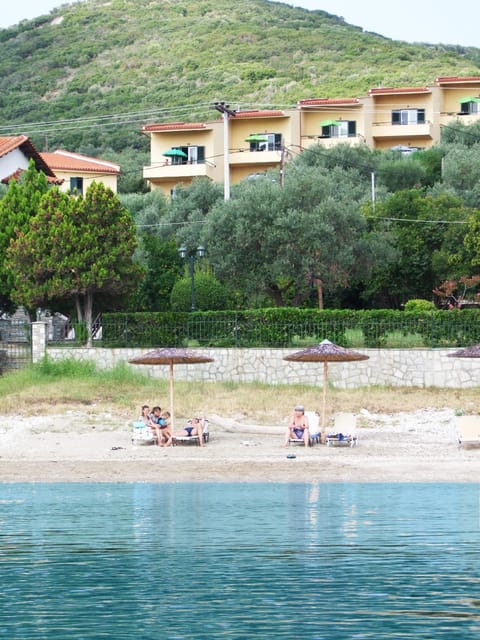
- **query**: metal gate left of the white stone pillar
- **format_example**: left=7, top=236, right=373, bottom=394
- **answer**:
left=0, top=317, right=32, bottom=373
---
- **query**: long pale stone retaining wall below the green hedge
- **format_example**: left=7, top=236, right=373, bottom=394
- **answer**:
left=45, top=347, right=480, bottom=389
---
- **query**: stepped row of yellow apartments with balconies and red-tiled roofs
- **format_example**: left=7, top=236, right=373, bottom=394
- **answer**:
left=143, top=76, right=480, bottom=196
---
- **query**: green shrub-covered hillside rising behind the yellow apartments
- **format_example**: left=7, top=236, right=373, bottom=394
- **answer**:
left=0, top=0, right=480, bottom=152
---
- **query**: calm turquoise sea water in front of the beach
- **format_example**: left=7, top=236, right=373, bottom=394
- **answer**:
left=0, top=483, right=480, bottom=640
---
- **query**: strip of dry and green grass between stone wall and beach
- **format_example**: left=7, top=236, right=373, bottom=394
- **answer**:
left=0, top=360, right=480, bottom=424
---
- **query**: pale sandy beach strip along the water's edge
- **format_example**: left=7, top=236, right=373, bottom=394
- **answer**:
left=0, top=408, right=480, bottom=482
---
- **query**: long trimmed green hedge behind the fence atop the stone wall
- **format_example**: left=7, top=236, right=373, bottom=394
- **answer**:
left=102, top=308, right=480, bottom=348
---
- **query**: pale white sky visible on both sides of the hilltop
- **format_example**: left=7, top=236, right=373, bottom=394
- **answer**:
left=0, top=0, right=480, bottom=47
